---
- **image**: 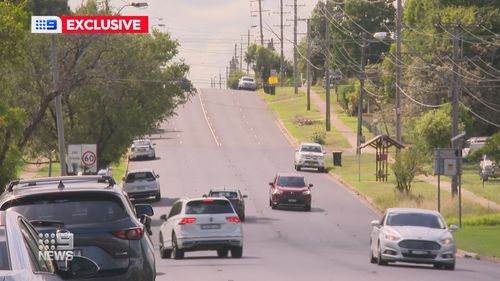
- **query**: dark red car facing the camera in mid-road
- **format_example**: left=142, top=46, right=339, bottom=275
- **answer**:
left=269, top=173, right=313, bottom=211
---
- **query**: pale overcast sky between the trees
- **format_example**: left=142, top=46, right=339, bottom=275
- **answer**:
left=69, top=0, right=318, bottom=88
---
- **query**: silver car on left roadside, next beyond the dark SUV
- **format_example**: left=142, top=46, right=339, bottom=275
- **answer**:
left=122, top=169, right=161, bottom=201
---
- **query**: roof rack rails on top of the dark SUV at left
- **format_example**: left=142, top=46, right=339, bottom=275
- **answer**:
left=7, top=175, right=116, bottom=192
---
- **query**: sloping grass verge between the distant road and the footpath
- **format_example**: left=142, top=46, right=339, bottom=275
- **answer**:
left=259, top=87, right=350, bottom=151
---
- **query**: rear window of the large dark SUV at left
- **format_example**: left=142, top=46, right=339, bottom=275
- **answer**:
left=2, top=192, right=128, bottom=225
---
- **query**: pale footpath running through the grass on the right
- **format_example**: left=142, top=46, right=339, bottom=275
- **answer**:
left=303, top=86, right=500, bottom=212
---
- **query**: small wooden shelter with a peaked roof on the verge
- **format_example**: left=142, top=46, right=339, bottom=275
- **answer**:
left=360, top=135, right=404, bottom=181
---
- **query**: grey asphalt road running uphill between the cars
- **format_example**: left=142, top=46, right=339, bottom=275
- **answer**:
left=130, top=89, right=500, bottom=281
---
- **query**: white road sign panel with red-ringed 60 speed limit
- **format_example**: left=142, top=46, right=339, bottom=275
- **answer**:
left=68, top=144, right=97, bottom=175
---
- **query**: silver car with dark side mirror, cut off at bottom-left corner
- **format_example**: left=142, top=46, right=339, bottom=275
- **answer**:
left=0, top=210, right=99, bottom=281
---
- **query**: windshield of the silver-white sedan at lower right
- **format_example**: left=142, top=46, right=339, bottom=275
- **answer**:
left=386, top=213, right=446, bottom=229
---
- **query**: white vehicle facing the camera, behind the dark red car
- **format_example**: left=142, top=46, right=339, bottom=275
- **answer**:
left=294, top=142, right=326, bottom=172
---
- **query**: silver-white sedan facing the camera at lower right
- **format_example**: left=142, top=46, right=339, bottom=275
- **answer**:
left=370, top=208, right=458, bottom=270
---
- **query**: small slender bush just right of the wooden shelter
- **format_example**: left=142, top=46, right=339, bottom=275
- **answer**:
left=391, top=148, right=422, bottom=196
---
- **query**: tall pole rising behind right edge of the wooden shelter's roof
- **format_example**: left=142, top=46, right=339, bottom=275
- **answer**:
left=396, top=0, right=403, bottom=143
